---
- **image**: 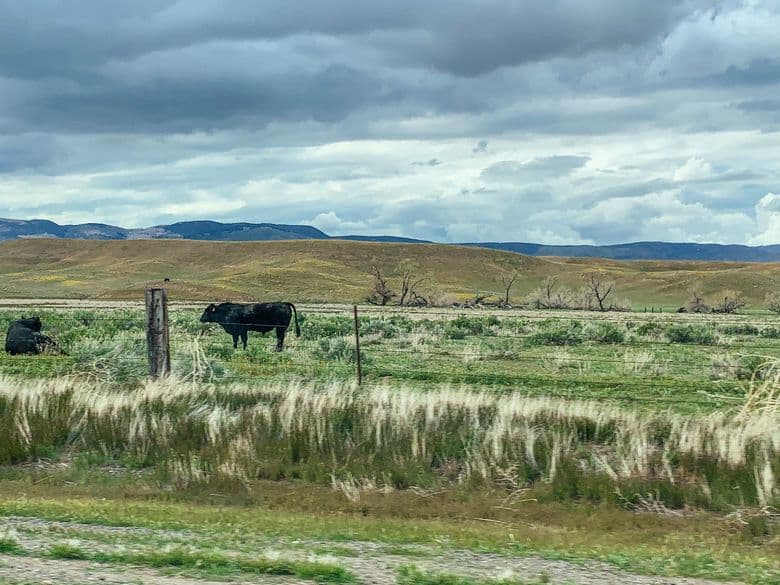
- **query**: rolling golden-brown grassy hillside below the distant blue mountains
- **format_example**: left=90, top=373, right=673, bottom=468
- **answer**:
left=0, top=239, right=780, bottom=308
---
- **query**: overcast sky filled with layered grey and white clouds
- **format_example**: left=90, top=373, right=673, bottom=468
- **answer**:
left=0, top=0, right=780, bottom=244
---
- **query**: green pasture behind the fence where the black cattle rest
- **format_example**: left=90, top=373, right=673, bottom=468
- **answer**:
left=0, top=307, right=780, bottom=411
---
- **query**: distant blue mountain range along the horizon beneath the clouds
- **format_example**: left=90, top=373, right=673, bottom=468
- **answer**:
left=0, top=219, right=780, bottom=262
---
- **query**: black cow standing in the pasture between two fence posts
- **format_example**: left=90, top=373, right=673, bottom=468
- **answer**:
left=200, top=303, right=301, bottom=351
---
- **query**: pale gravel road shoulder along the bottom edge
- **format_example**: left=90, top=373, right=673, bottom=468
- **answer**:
left=0, top=518, right=744, bottom=585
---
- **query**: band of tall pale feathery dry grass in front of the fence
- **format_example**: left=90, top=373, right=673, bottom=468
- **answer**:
left=0, top=370, right=780, bottom=508
